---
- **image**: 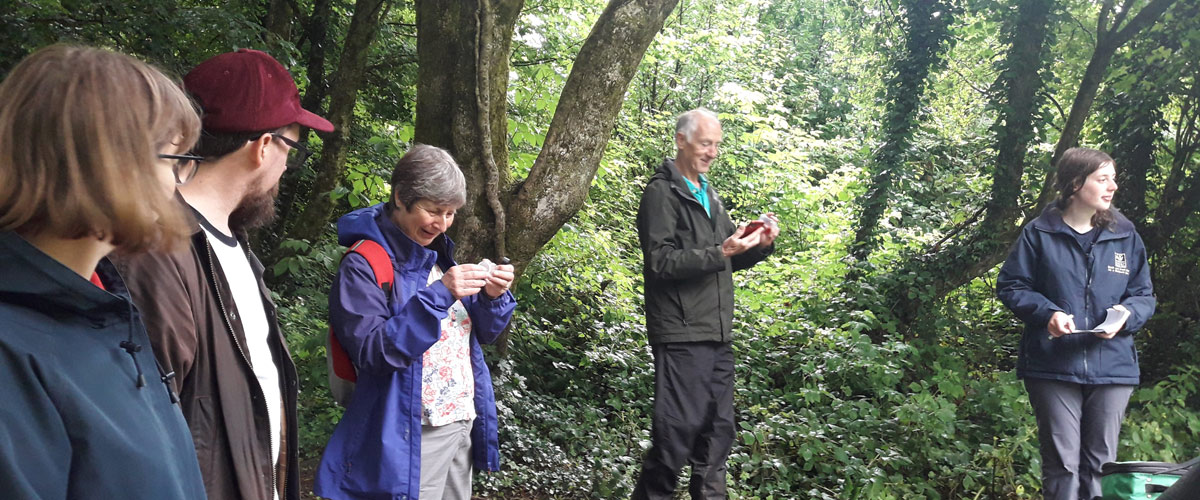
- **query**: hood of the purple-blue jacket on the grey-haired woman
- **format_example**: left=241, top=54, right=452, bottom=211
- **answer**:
left=337, top=203, right=454, bottom=267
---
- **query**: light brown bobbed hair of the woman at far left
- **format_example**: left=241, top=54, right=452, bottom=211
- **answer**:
left=0, top=46, right=200, bottom=252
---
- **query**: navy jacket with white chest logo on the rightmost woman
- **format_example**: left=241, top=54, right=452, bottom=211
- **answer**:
left=996, top=205, right=1156, bottom=385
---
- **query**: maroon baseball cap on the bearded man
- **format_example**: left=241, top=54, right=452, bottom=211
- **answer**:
left=184, top=49, right=334, bottom=133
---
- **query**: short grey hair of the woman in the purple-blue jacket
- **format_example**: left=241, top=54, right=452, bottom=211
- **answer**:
left=391, top=144, right=467, bottom=209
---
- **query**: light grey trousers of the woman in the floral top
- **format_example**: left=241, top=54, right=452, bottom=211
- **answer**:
left=421, top=420, right=474, bottom=500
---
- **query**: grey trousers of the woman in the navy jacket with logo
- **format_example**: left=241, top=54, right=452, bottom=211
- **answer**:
left=1025, top=378, right=1134, bottom=500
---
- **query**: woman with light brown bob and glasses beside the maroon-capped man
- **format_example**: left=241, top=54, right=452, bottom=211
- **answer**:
left=0, top=46, right=204, bottom=499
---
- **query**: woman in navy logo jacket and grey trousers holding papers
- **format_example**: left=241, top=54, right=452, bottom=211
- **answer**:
left=996, top=147, right=1154, bottom=500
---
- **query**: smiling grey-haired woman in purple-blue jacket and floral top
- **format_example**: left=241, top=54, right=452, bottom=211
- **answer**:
left=316, top=145, right=516, bottom=500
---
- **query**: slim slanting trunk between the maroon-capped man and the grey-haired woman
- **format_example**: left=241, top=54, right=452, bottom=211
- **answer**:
left=288, top=0, right=385, bottom=241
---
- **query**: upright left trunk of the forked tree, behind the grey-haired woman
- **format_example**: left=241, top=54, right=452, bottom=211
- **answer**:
left=414, top=0, right=524, bottom=261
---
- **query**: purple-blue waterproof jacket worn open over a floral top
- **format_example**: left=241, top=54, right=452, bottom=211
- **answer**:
left=314, top=204, right=516, bottom=500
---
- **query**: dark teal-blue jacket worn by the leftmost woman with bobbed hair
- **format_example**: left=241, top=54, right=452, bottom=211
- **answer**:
left=0, top=233, right=205, bottom=500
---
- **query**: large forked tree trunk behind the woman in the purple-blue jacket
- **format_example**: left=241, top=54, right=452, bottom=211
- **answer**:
left=415, top=0, right=677, bottom=273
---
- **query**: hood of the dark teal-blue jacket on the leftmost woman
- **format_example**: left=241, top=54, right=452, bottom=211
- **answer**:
left=0, top=231, right=128, bottom=317
